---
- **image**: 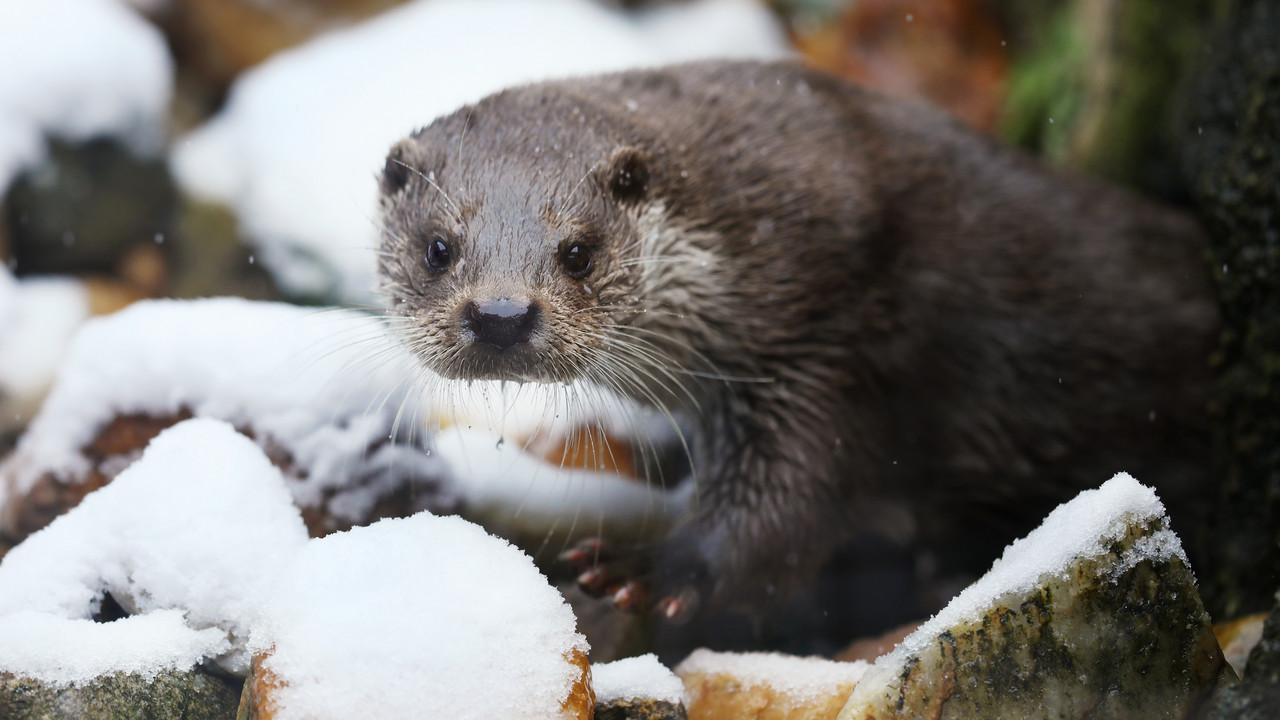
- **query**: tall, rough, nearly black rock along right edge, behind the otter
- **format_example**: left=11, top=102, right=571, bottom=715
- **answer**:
left=1184, top=0, right=1280, bottom=618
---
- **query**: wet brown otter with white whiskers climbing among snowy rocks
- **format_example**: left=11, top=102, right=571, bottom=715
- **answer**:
left=379, top=61, right=1219, bottom=619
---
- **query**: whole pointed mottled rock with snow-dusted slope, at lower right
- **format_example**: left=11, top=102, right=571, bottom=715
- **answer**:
left=840, top=475, right=1230, bottom=720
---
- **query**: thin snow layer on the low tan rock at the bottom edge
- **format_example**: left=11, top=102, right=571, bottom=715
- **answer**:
left=676, top=650, right=869, bottom=701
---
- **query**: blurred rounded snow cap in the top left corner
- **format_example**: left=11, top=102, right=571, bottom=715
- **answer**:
left=0, top=0, right=173, bottom=195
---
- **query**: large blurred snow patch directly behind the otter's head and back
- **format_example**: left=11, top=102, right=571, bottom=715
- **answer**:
left=173, top=0, right=788, bottom=302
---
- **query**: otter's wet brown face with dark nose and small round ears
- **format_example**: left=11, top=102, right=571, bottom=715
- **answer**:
left=379, top=128, right=649, bottom=383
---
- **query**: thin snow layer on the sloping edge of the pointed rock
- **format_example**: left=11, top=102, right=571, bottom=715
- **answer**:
left=891, top=473, right=1187, bottom=659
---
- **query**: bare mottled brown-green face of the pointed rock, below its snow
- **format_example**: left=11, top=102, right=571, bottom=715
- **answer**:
left=840, top=504, right=1231, bottom=720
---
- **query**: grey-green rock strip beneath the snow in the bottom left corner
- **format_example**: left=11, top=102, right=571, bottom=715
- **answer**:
left=0, top=669, right=241, bottom=720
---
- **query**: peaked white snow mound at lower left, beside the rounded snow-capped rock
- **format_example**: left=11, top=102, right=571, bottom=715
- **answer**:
left=0, top=419, right=307, bottom=683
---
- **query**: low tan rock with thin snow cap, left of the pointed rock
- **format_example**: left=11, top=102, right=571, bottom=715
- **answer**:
left=676, top=650, right=868, bottom=720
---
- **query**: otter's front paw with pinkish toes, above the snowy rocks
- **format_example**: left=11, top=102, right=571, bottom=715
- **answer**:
left=561, top=538, right=705, bottom=623
